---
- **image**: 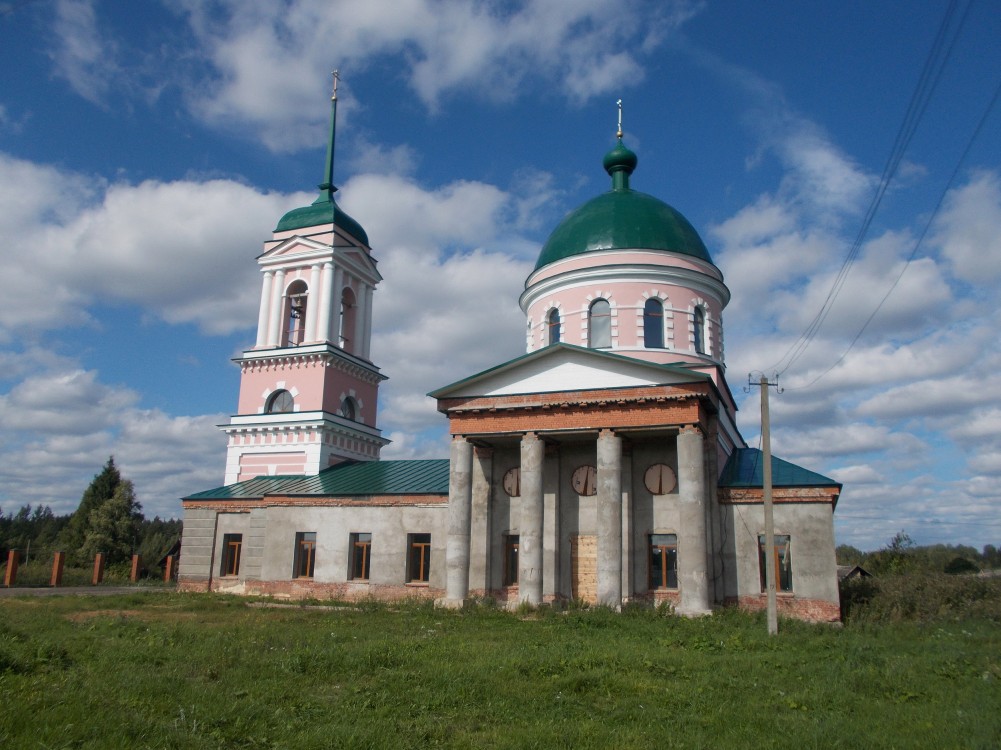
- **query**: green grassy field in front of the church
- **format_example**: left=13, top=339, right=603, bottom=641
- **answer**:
left=0, top=592, right=1001, bottom=748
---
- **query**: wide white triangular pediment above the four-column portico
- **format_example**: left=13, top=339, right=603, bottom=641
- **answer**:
left=431, top=344, right=707, bottom=399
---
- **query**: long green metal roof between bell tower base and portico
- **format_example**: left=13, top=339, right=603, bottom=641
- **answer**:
left=184, top=459, right=448, bottom=500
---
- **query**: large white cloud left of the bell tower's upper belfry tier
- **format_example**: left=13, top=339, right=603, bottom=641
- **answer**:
left=0, top=154, right=296, bottom=340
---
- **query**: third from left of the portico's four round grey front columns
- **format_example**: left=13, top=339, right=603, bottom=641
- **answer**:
left=597, top=430, right=623, bottom=609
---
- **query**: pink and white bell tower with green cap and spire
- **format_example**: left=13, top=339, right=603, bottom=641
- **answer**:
left=221, top=72, right=388, bottom=485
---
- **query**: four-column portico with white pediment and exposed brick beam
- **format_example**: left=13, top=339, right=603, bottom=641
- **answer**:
left=432, top=344, right=719, bottom=614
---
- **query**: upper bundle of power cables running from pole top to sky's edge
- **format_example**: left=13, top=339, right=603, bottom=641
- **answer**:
left=772, top=0, right=972, bottom=374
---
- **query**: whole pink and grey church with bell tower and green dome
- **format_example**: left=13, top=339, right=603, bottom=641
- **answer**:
left=179, top=92, right=841, bottom=621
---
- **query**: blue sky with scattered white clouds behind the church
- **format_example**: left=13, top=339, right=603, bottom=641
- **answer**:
left=0, top=0, right=1001, bottom=549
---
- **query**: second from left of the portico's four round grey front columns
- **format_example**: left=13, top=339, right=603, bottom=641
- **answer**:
left=518, top=433, right=546, bottom=605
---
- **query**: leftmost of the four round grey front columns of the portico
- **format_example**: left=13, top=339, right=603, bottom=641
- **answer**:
left=443, top=436, right=472, bottom=607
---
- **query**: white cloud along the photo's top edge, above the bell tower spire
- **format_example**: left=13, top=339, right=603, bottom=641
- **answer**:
left=176, top=0, right=700, bottom=150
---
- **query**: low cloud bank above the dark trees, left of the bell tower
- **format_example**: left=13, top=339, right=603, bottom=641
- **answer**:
left=0, top=360, right=225, bottom=518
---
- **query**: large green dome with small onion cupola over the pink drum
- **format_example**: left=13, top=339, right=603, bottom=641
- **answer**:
left=536, top=140, right=713, bottom=270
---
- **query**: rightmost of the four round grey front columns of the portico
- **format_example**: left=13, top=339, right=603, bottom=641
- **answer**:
left=678, top=427, right=710, bottom=616
